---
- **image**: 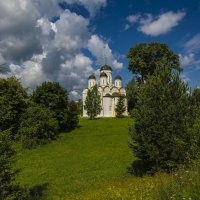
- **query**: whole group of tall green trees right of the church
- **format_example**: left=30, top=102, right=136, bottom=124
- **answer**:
left=127, top=42, right=200, bottom=175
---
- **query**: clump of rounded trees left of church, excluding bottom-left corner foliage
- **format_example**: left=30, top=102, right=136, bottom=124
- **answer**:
left=0, top=77, right=78, bottom=148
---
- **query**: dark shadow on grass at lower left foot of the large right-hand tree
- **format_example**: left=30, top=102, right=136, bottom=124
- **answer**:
left=128, top=160, right=150, bottom=177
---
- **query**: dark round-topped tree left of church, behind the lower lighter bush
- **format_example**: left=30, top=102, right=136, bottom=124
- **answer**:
left=32, top=82, right=68, bottom=130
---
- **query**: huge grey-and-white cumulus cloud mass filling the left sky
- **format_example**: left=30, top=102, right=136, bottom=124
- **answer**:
left=0, top=0, right=122, bottom=98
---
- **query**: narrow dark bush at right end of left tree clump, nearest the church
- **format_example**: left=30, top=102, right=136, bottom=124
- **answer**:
left=67, top=101, right=79, bottom=130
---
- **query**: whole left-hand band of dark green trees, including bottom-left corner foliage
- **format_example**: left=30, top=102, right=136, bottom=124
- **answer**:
left=0, top=77, right=79, bottom=200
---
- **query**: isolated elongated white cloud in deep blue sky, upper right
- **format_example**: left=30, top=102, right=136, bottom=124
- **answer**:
left=125, top=11, right=186, bottom=36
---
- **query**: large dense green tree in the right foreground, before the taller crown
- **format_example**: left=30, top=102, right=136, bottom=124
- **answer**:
left=130, top=68, right=189, bottom=173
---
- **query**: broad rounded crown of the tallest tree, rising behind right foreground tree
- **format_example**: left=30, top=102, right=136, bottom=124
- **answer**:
left=127, top=42, right=182, bottom=83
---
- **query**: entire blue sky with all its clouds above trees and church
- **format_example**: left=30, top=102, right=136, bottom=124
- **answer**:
left=0, top=0, right=200, bottom=99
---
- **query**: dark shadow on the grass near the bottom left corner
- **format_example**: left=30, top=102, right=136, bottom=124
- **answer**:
left=30, top=183, right=48, bottom=200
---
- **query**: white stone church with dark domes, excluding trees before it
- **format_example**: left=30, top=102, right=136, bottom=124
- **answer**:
left=82, top=65, right=128, bottom=117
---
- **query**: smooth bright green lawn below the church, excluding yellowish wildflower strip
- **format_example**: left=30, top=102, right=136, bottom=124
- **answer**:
left=16, top=118, right=133, bottom=199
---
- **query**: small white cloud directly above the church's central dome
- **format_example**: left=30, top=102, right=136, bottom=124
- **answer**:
left=87, top=35, right=123, bottom=69
